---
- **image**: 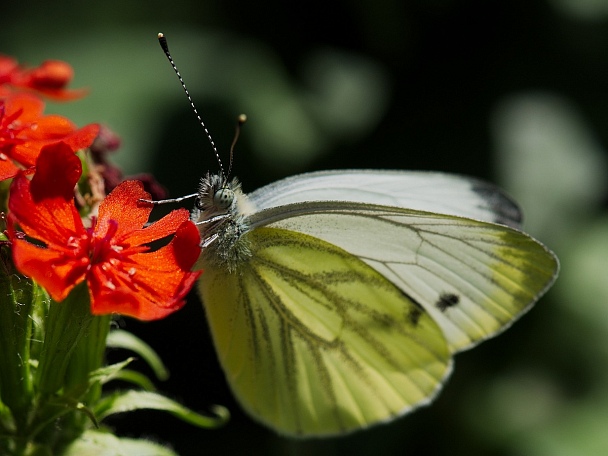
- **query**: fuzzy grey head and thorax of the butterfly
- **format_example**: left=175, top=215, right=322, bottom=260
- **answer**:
left=191, top=174, right=251, bottom=272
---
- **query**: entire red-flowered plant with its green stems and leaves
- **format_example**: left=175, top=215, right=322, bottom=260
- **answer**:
left=0, top=56, right=216, bottom=455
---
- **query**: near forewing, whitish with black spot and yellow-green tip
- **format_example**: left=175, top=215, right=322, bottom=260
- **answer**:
left=252, top=201, right=559, bottom=352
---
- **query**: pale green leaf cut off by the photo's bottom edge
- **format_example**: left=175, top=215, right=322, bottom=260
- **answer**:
left=62, top=430, right=177, bottom=456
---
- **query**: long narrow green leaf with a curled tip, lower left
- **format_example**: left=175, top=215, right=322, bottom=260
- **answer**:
left=95, top=391, right=230, bottom=428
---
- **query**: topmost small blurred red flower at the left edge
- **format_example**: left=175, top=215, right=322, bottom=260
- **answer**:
left=0, top=55, right=87, bottom=101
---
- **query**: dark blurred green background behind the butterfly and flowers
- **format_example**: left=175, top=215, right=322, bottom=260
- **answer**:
left=0, top=0, right=608, bottom=456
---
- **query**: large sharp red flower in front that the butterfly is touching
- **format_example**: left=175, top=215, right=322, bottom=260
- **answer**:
left=9, top=143, right=200, bottom=320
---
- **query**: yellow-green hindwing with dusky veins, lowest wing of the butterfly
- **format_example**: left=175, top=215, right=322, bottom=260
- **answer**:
left=199, top=228, right=451, bottom=436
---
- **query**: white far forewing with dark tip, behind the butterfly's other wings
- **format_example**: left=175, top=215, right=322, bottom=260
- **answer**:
left=248, top=169, right=521, bottom=228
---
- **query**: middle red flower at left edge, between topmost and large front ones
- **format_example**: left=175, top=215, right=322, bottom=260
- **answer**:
left=0, top=93, right=99, bottom=181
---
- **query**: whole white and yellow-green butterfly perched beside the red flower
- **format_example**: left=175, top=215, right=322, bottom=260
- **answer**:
left=161, top=33, right=559, bottom=437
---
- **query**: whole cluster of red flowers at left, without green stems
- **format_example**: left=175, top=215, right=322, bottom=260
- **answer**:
left=0, top=57, right=199, bottom=320
